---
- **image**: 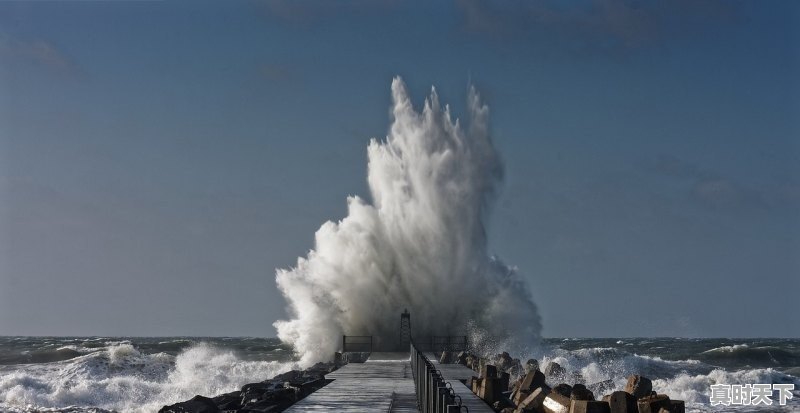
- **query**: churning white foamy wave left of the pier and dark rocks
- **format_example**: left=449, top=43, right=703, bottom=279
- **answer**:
left=0, top=343, right=297, bottom=412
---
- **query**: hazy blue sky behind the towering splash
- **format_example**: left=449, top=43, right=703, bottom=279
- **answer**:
left=0, top=0, right=800, bottom=337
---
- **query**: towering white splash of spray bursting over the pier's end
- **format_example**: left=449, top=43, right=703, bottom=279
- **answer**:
left=274, top=78, right=541, bottom=365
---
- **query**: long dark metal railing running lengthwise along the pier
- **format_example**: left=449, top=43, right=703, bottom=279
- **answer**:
left=411, top=338, right=469, bottom=413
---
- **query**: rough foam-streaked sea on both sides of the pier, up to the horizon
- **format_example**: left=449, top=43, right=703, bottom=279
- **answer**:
left=0, top=337, right=800, bottom=413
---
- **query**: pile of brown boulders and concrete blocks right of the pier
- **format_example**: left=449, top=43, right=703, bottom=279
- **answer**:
left=456, top=353, right=686, bottom=413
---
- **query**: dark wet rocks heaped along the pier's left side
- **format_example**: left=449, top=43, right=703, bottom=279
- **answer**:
left=158, top=360, right=340, bottom=413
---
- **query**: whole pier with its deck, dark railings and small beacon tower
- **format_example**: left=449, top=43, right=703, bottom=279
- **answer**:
left=286, top=311, right=494, bottom=413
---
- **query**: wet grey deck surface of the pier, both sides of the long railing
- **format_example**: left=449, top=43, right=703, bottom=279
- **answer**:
left=286, top=353, right=493, bottom=413
